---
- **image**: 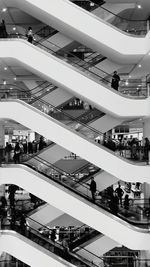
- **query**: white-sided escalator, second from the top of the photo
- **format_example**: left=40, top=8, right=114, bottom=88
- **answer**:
left=0, top=39, right=149, bottom=119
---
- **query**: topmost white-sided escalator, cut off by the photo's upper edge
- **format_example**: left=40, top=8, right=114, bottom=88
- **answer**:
left=6, top=0, right=149, bottom=63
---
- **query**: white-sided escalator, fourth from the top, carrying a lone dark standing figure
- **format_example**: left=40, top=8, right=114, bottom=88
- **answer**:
left=0, top=165, right=150, bottom=250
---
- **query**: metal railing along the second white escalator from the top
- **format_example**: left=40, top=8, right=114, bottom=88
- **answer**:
left=0, top=30, right=147, bottom=98
